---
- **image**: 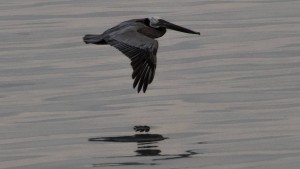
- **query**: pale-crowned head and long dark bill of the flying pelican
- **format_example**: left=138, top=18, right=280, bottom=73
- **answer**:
left=147, top=16, right=200, bottom=35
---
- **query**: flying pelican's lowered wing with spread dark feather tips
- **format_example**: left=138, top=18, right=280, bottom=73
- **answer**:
left=105, top=27, right=158, bottom=93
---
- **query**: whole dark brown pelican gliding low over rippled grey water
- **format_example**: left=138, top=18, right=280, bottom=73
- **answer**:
left=83, top=17, right=200, bottom=93
